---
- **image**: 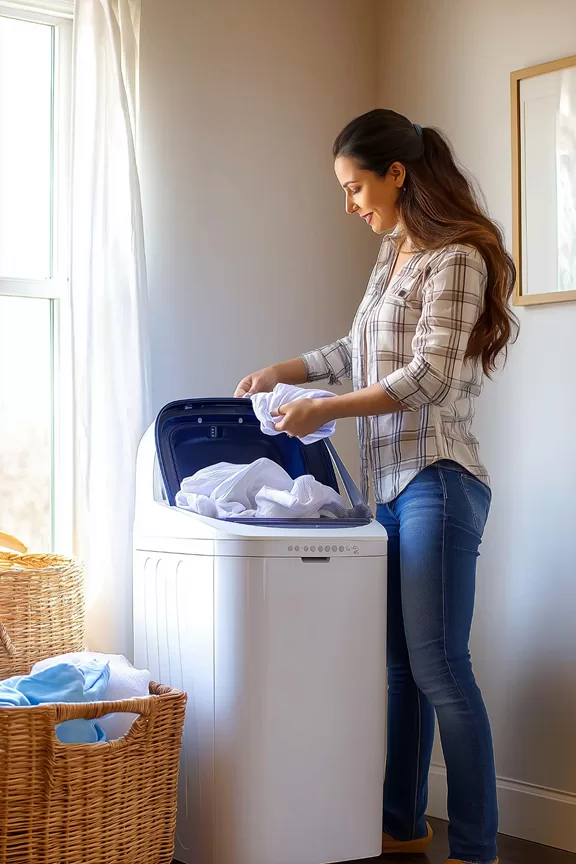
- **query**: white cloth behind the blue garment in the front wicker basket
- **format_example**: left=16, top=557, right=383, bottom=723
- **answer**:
left=32, top=651, right=150, bottom=741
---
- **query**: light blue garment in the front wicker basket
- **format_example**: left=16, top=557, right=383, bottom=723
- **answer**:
left=0, top=660, right=110, bottom=744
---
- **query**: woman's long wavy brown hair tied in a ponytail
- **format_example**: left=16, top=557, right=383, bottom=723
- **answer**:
left=333, top=109, right=518, bottom=375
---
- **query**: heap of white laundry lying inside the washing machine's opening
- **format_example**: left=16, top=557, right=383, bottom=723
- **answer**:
left=176, top=459, right=347, bottom=519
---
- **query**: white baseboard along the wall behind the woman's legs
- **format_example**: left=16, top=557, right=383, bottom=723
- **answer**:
left=428, top=765, right=576, bottom=852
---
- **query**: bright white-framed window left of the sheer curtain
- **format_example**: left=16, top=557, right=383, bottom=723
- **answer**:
left=0, top=0, right=71, bottom=551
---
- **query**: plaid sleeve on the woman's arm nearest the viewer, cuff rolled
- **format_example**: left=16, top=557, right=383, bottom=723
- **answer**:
left=380, top=250, right=486, bottom=411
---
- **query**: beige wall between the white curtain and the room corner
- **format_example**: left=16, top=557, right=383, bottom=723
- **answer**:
left=141, top=0, right=377, bottom=467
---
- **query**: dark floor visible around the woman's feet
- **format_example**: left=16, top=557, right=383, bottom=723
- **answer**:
left=173, top=819, right=576, bottom=864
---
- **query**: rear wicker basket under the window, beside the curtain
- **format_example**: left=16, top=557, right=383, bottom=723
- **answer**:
left=0, top=548, right=84, bottom=680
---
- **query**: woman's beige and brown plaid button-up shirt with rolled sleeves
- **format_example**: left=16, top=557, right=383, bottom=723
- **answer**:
left=302, top=235, right=489, bottom=503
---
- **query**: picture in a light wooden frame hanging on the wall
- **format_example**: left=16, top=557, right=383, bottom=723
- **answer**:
left=510, top=56, right=576, bottom=306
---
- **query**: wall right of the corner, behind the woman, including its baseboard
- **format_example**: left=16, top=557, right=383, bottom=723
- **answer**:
left=379, top=0, right=576, bottom=850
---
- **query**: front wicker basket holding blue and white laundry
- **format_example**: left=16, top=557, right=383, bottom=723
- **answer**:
left=0, top=684, right=186, bottom=864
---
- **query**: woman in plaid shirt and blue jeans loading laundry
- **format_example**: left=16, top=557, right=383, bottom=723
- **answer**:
left=236, top=110, right=515, bottom=864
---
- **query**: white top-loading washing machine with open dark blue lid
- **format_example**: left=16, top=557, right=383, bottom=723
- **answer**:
left=134, top=399, right=386, bottom=864
